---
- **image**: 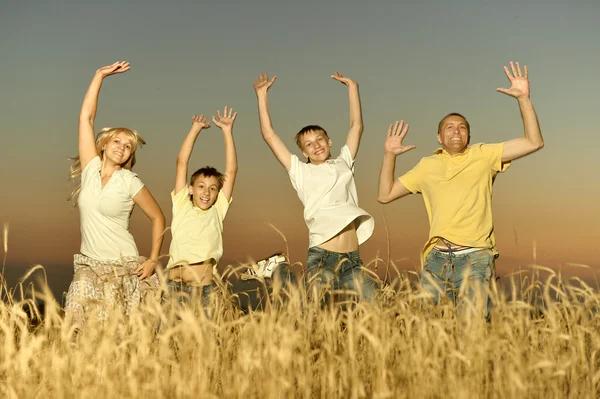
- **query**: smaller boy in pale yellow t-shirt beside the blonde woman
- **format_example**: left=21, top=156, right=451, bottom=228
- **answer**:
left=167, top=106, right=237, bottom=306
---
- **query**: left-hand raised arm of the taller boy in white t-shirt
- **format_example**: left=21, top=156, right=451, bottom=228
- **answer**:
left=252, top=73, right=292, bottom=171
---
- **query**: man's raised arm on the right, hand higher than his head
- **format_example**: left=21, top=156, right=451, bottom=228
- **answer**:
left=497, top=62, right=544, bottom=162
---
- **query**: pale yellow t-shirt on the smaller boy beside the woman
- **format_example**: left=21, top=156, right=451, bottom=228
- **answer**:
left=167, top=186, right=233, bottom=268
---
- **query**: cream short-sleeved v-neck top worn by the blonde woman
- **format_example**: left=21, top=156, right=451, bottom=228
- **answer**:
left=78, top=157, right=144, bottom=261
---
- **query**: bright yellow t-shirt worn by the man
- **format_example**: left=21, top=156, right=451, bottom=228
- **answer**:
left=399, top=143, right=510, bottom=264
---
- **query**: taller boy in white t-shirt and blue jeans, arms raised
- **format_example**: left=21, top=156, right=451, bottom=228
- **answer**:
left=253, top=72, right=377, bottom=301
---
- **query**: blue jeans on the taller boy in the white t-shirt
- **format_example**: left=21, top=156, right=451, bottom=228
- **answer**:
left=304, top=247, right=379, bottom=302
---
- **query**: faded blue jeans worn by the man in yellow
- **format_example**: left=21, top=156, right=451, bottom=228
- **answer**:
left=421, top=249, right=496, bottom=318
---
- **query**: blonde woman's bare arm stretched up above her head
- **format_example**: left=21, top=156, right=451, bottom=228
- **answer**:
left=79, top=61, right=130, bottom=170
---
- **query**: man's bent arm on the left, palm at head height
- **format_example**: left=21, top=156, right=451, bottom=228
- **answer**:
left=377, top=121, right=416, bottom=204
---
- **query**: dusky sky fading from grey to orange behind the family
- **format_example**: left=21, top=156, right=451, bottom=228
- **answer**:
left=0, top=0, right=600, bottom=296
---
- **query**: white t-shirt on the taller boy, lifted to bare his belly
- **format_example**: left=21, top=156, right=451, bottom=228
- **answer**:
left=289, top=146, right=375, bottom=248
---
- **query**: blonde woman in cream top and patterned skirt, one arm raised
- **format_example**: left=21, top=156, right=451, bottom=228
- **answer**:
left=65, top=61, right=165, bottom=323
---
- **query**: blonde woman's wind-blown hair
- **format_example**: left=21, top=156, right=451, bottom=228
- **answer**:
left=67, top=127, right=146, bottom=206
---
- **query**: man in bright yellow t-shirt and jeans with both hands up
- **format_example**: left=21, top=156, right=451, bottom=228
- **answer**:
left=377, top=62, right=544, bottom=317
